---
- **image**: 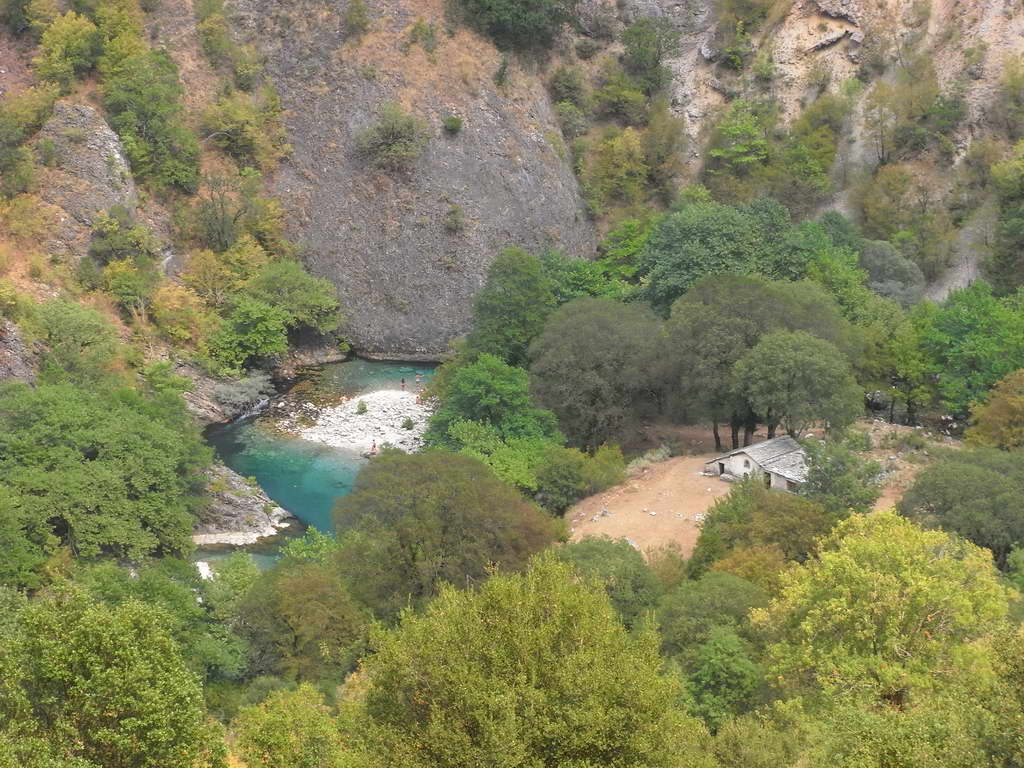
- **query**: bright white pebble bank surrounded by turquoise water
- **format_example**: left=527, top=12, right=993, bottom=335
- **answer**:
left=299, top=389, right=432, bottom=454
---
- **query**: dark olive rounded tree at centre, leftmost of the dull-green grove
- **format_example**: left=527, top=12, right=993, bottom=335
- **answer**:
left=530, top=299, right=660, bottom=449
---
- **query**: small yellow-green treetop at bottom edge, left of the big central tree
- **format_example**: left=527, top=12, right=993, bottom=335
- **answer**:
left=231, top=683, right=344, bottom=768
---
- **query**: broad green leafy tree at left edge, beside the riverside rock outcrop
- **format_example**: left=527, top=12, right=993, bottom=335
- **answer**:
left=0, top=384, right=210, bottom=573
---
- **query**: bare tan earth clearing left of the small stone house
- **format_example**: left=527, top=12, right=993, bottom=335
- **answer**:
left=565, top=454, right=731, bottom=557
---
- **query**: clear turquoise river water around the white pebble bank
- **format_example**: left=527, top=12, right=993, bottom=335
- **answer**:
left=200, top=359, right=433, bottom=559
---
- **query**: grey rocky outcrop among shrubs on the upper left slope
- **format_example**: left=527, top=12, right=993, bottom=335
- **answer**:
left=35, top=102, right=135, bottom=263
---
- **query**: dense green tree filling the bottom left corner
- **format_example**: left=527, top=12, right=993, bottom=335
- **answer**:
left=0, top=589, right=218, bottom=768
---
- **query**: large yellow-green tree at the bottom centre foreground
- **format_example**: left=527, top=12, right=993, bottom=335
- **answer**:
left=349, top=556, right=709, bottom=768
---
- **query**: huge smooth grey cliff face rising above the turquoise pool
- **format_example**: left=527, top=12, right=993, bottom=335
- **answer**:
left=233, top=0, right=595, bottom=359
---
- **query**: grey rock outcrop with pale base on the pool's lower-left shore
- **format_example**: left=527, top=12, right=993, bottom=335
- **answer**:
left=193, top=464, right=295, bottom=547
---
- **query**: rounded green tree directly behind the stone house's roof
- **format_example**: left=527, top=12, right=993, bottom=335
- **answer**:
left=733, top=331, right=862, bottom=438
